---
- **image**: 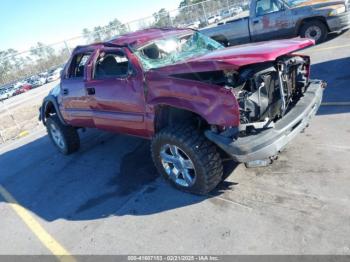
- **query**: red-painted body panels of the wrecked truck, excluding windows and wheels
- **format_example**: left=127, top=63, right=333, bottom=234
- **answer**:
left=58, top=29, right=314, bottom=138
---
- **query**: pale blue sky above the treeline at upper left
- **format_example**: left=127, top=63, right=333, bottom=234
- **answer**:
left=0, top=0, right=180, bottom=51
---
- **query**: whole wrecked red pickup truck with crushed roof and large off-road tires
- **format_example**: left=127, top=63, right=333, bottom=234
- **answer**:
left=40, top=29, right=326, bottom=194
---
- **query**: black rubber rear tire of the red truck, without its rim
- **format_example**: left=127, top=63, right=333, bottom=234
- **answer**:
left=46, top=115, right=80, bottom=155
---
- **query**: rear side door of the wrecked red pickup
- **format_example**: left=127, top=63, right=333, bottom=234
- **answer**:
left=59, top=50, right=94, bottom=127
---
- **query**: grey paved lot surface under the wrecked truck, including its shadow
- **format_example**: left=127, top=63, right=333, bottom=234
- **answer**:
left=0, top=32, right=350, bottom=254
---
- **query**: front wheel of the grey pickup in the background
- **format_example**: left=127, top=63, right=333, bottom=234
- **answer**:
left=299, top=20, right=328, bottom=44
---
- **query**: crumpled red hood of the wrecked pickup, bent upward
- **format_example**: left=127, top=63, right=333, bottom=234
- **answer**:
left=153, top=38, right=315, bottom=74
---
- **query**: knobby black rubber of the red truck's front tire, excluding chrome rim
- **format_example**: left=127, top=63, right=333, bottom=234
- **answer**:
left=151, top=126, right=223, bottom=195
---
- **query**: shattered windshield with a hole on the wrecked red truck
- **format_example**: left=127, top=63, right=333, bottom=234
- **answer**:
left=135, top=32, right=224, bottom=70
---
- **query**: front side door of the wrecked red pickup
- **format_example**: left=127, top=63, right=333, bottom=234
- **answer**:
left=85, top=48, right=145, bottom=136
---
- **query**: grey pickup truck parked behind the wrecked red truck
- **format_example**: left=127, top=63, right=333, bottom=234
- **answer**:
left=201, top=0, right=350, bottom=45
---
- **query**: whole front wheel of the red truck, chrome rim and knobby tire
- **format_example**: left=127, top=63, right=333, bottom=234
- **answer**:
left=151, top=126, right=223, bottom=194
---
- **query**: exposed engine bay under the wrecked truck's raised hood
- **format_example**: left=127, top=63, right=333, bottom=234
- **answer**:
left=171, top=55, right=310, bottom=132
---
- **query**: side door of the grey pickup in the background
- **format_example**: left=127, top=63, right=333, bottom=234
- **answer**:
left=249, top=0, right=295, bottom=42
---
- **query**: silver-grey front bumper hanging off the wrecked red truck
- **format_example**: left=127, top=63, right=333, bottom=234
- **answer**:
left=205, top=80, right=325, bottom=163
